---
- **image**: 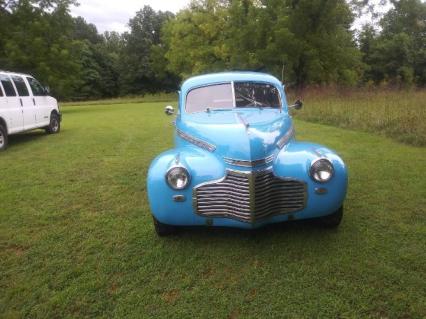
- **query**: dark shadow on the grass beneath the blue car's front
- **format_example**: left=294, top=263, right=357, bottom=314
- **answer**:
left=146, top=220, right=346, bottom=264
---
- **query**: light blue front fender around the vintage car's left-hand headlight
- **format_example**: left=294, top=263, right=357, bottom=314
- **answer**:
left=147, top=145, right=225, bottom=225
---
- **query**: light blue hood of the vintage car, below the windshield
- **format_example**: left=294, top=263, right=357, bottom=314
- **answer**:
left=176, top=109, right=292, bottom=161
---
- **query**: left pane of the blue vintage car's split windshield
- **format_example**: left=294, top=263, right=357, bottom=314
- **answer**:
left=186, top=83, right=234, bottom=113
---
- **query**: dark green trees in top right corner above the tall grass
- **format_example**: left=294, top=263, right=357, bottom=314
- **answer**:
left=360, top=0, right=426, bottom=86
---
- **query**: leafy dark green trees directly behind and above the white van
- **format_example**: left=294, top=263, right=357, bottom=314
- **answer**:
left=0, top=0, right=79, bottom=98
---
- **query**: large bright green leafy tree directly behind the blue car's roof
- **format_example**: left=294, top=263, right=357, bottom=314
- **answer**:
left=165, top=0, right=361, bottom=86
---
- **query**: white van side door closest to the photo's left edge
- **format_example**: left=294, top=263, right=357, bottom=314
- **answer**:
left=0, top=74, right=24, bottom=134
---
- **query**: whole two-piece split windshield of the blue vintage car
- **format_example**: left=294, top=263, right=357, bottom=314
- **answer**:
left=186, top=82, right=281, bottom=113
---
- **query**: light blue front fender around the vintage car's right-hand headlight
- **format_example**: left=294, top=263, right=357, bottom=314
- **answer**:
left=273, top=141, right=348, bottom=219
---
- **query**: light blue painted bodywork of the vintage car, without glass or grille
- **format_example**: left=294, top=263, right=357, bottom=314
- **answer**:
left=147, top=72, right=347, bottom=228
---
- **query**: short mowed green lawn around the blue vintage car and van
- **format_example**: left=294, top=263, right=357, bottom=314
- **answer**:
left=0, top=103, right=426, bottom=318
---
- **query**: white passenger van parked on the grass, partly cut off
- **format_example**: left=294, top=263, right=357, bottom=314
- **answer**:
left=0, top=70, right=61, bottom=151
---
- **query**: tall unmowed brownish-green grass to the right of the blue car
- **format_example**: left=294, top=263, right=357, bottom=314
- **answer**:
left=295, top=89, right=426, bottom=146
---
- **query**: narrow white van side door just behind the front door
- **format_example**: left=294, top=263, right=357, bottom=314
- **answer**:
left=11, top=75, right=37, bottom=130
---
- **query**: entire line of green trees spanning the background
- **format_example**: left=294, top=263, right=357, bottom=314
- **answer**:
left=0, top=0, right=426, bottom=100
